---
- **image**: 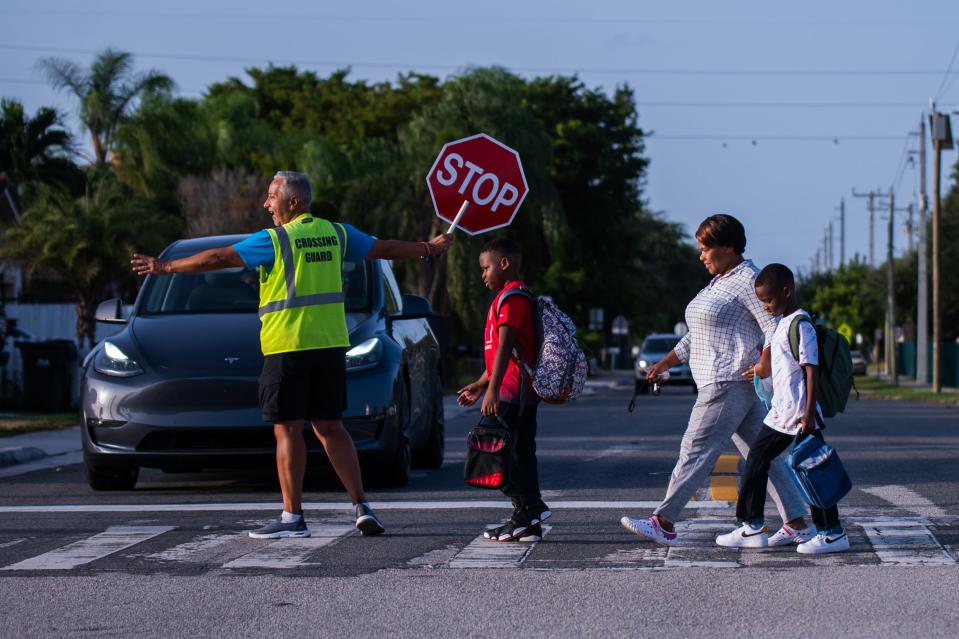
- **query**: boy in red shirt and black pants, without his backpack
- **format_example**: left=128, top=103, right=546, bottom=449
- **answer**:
left=458, top=238, right=552, bottom=542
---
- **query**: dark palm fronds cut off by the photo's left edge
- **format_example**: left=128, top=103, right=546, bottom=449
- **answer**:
left=0, top=99, right=79, bottom=191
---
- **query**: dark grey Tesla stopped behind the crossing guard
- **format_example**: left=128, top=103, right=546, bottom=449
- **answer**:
left=81, top=236, right=444, bottom=490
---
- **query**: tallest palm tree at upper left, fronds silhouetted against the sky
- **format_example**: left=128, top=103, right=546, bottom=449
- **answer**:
left=40, top=49, right=174, bottom=166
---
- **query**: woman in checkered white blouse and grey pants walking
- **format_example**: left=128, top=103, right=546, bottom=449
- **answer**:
left=620, top=214, right=816, bottom=546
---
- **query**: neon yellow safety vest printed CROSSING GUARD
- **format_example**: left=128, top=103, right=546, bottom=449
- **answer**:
left=259, top=213, right=350, bottom=355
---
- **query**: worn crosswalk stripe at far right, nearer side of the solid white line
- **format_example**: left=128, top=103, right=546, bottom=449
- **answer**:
left=856, top=519, right=956, bottom=566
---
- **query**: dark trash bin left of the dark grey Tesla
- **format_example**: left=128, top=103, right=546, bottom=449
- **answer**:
left=17, top=339, right=77, bottom=411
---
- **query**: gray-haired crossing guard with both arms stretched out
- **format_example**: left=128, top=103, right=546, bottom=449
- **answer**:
left=132, top=171, right=453, bottom=539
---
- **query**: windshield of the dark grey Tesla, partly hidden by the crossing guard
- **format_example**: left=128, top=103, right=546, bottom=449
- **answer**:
left=141, top=262, right=370, bottom=315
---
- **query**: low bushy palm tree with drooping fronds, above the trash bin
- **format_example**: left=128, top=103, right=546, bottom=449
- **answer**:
left=0, top=172, right=180, bottom=350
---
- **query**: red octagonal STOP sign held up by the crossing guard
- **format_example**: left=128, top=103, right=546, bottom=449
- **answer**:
left=426, top=133, right=529, bottom=235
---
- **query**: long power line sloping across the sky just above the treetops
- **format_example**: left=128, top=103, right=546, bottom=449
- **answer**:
left=0, top=44, right=941, bottom=76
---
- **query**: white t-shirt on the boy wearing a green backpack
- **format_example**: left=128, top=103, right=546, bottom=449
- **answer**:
left=764, top=309, right=821, bottom=435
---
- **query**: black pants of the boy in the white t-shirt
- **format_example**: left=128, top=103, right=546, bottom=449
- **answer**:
left=736, top=426, right=839, bottom=531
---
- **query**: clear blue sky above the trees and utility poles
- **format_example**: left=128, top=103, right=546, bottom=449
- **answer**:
left=0, top=0, right=959, bottom=276
